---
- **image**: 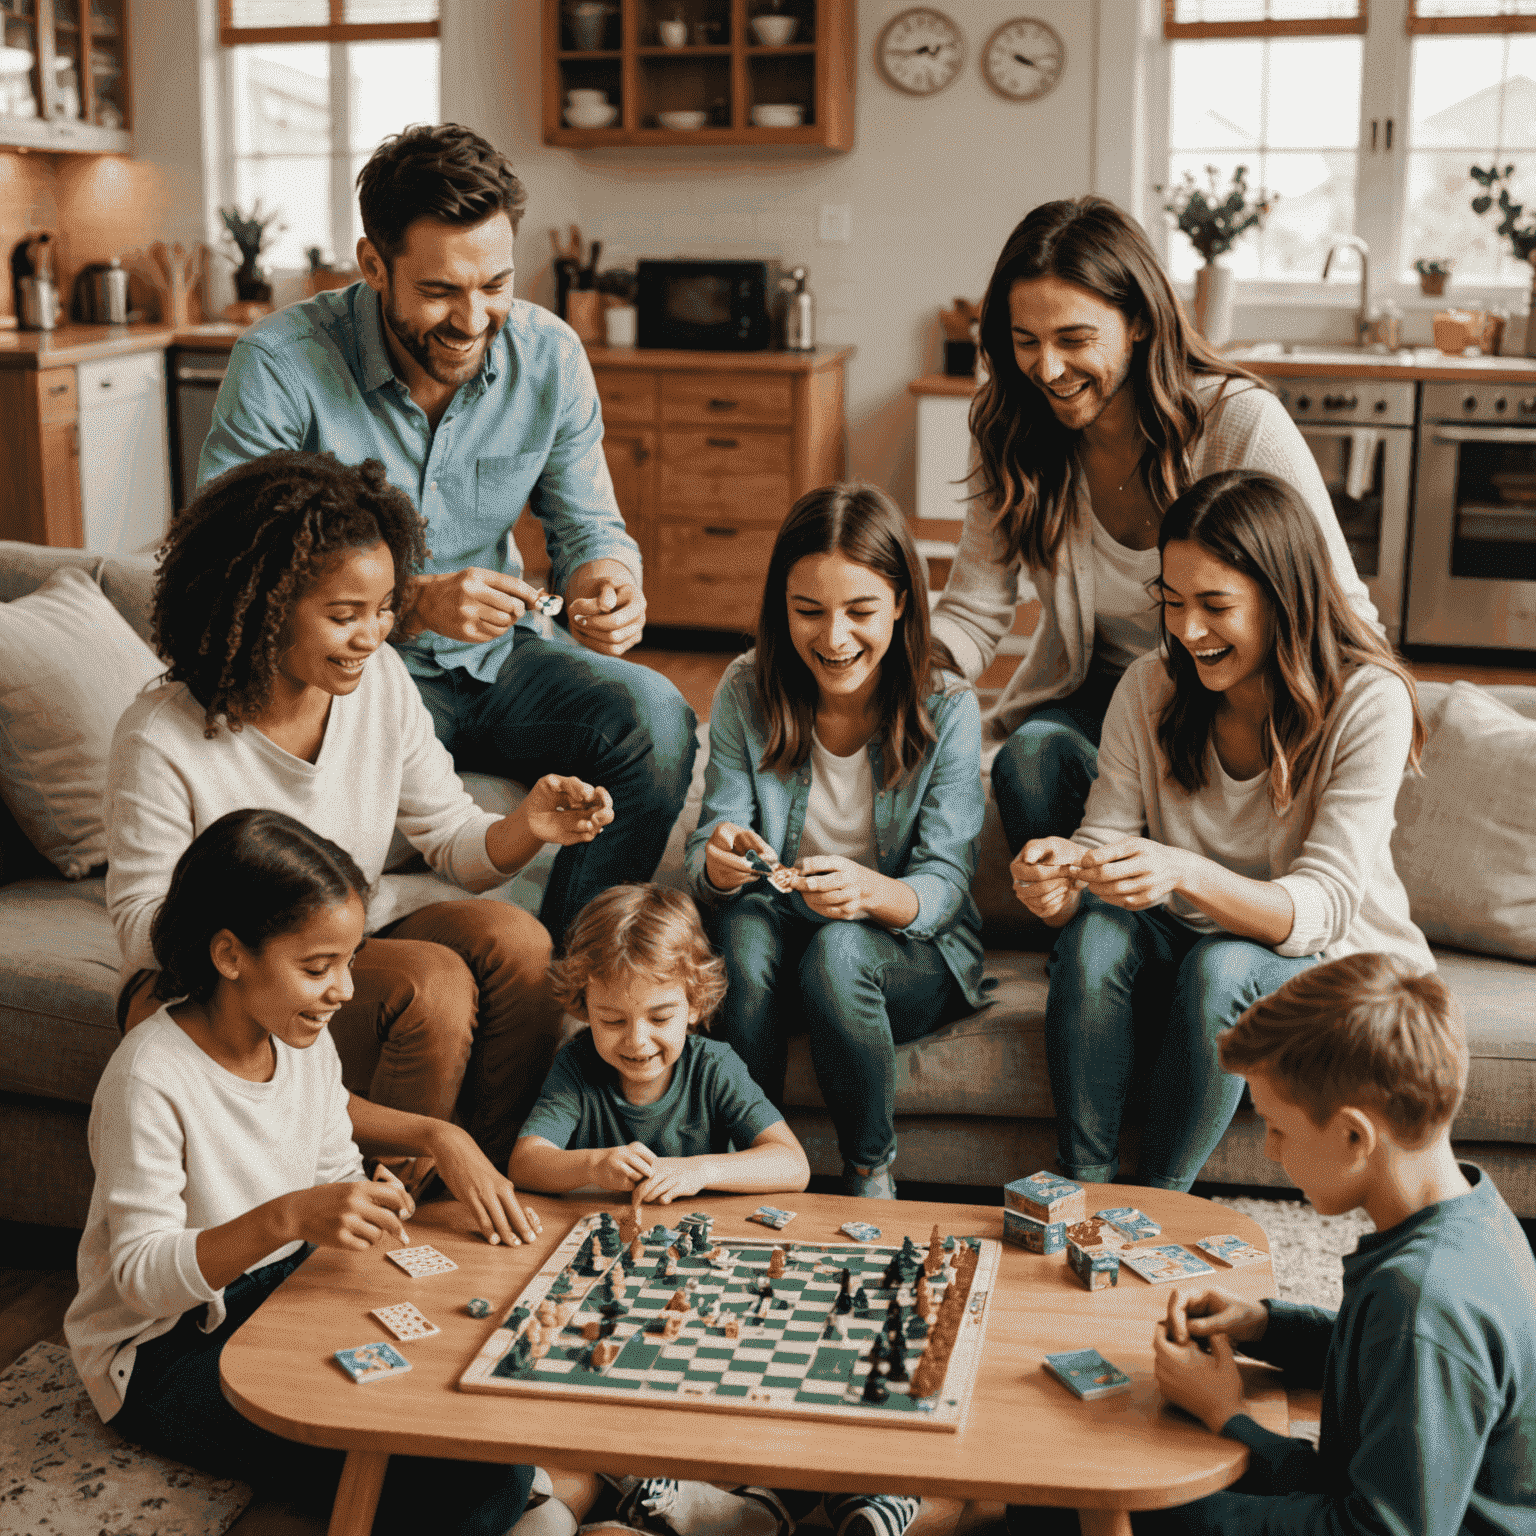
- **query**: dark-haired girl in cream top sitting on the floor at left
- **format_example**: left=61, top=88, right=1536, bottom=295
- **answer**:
left=65, top=811, right=533, bottom=1536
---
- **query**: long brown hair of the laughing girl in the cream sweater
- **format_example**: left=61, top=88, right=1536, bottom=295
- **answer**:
left=1157, top=470, right=1425, bottom=813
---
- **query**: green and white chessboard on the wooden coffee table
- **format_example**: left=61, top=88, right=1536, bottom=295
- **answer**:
left=459, top=1217, right=1000, bottom=1432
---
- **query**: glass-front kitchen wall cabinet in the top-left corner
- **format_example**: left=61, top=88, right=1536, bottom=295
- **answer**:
left=0, top=0, right=132, bottom=154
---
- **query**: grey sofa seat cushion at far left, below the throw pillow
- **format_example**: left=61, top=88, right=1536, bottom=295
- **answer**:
left=0, top=877, right=120, bottom=1104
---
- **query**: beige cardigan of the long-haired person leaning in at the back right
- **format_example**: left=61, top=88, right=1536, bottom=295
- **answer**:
left=934, top=378, right=1381, bottom=739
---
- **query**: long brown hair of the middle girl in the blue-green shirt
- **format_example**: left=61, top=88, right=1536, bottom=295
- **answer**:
left=754, top=482, right=958, bottom=788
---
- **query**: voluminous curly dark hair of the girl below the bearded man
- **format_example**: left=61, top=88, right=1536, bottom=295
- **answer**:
left=151, top=452, right=427, bottom=736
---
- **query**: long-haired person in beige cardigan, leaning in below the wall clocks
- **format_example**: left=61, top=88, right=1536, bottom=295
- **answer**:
left=934, top=197, right=1376, bottom=849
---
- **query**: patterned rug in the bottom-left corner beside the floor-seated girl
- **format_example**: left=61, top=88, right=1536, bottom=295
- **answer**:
left=0, top=1344, right=250, bottom=1536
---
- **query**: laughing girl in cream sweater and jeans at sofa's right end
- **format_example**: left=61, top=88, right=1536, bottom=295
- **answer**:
left=1012, top=470, right=1435, bottom=1189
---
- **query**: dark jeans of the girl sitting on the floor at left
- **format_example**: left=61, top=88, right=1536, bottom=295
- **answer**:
left=112, top=1249, right=533, bottom=1536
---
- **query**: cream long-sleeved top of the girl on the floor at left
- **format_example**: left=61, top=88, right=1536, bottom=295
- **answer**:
left=65, top=1008, right=362, bottom=1419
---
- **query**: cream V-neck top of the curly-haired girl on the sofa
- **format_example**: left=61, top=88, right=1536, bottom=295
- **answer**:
left=106, top=645, right=505, bottom=975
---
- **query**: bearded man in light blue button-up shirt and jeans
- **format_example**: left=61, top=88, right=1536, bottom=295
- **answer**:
left=198, top=124, right=697, bottom=945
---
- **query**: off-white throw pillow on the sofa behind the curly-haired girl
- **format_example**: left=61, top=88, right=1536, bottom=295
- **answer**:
left=0, top=565, right=164, bottom=880
